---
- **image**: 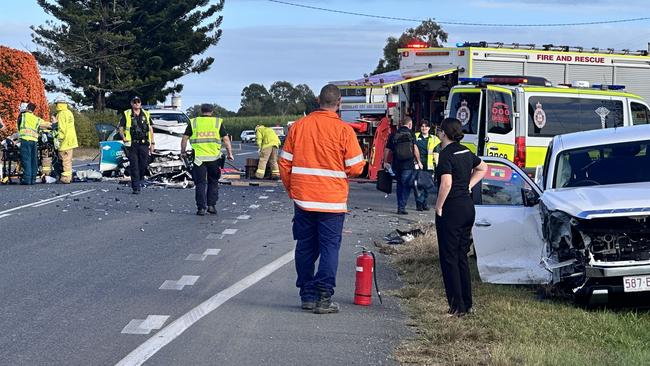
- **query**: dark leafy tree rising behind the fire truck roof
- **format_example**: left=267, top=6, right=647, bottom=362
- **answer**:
left=372, top=19, right=448, bottom=74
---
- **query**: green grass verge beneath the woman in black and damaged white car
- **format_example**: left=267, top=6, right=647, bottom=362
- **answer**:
left=388, top=226, right=650, bottom=366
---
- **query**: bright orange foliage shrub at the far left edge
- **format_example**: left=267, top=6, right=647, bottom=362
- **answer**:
left=0, top=46, right=50, bottom=137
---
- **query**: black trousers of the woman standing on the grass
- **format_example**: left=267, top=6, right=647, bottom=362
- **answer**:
left=436, top=196, right=475, bottom=313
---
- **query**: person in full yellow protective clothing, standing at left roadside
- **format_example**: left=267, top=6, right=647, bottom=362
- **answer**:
left=54, top=98, right=79, bottom=184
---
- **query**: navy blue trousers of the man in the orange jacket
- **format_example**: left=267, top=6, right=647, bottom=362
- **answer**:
left=293, top=206, right=345, bottom=301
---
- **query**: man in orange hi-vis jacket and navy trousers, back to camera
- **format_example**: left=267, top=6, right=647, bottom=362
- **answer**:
left=280, top=84, right=366, bottom=314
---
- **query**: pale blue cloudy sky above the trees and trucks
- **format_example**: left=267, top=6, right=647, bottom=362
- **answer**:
left=0, top=0, right=650, bottom=111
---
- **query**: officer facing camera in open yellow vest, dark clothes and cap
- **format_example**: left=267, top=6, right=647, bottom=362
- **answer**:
left=120, top=97, right=156, bottom=194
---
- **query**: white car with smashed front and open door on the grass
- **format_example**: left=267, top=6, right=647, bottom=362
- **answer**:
left=472, top=125, right=650, bottom=304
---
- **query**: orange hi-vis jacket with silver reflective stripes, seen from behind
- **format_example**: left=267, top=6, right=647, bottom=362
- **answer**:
left=279, top=110, right=366, bottom=212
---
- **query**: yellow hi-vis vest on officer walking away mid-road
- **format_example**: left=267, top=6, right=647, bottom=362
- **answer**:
left=190, top=117, right=223, bottom=161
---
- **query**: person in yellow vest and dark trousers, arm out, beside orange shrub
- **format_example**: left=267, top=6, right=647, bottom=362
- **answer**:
left=18, top=103, right=52, bottom=185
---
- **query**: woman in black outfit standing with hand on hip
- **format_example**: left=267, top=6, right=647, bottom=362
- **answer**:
left=436, top=118, right=487, bottom=316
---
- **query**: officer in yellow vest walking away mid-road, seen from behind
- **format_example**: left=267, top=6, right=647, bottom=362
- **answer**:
left=181, top=104, right=234, bottom=216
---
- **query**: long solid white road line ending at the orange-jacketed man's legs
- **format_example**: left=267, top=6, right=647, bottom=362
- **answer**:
left=116, top=250, right=293, bottom=366
